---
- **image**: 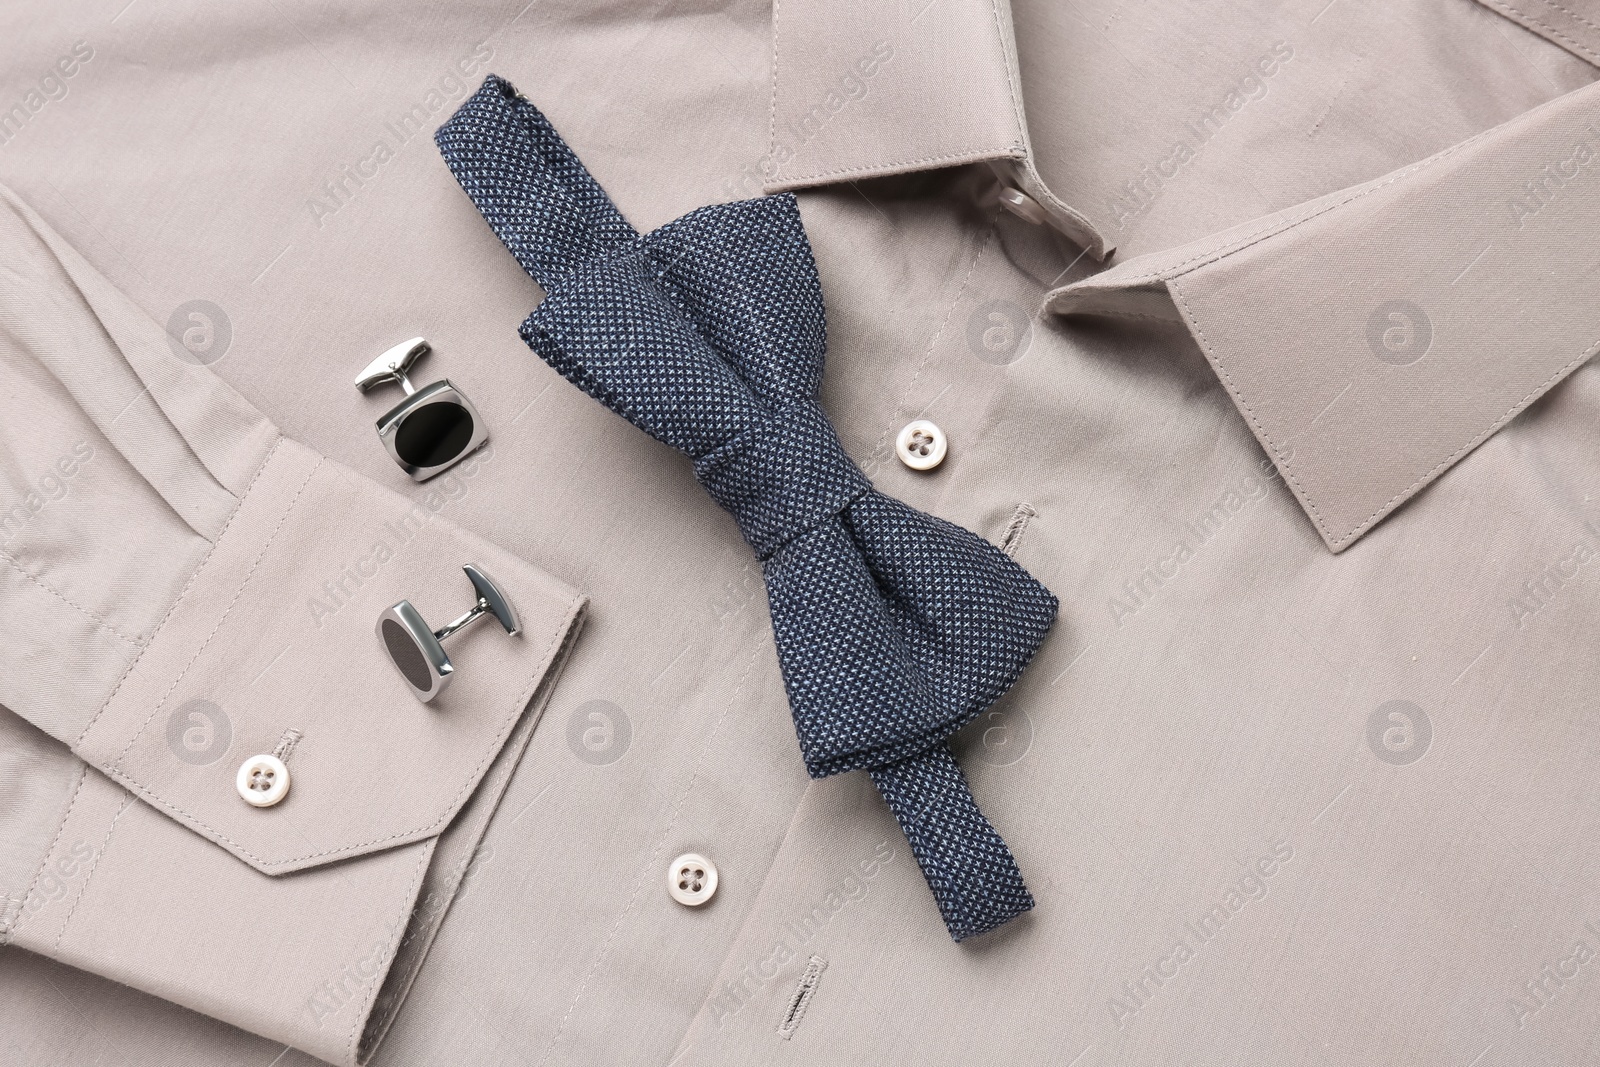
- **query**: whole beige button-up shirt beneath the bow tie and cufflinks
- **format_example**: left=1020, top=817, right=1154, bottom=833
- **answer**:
left=0, top=0, right=1600, bottom=1067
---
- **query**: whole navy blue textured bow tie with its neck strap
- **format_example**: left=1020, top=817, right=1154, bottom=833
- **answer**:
left=435, top=75, right=1056, bottom=941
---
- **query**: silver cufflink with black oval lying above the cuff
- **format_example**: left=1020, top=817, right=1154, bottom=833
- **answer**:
left=355, top=338, right=490, bottom=482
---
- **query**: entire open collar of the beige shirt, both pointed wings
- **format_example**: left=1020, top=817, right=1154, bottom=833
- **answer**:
left=766, top=0, right=1600, bottom=552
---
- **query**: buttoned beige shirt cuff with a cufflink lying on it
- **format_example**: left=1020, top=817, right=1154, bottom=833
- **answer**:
left=11, top=438, right=584, bottom=1064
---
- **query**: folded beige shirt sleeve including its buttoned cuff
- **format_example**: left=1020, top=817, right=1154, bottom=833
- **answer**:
left=0, top=179, right=584, bottom=1064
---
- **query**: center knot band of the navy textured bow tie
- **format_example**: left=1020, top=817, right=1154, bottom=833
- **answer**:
left=694, top=400, right=872, bottom=561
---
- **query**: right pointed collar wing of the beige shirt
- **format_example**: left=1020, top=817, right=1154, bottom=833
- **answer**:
left=1045, top=83, right=1600, bottom=552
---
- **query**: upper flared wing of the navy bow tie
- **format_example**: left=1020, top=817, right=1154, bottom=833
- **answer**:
left=522, top=197, right=832, bottom=459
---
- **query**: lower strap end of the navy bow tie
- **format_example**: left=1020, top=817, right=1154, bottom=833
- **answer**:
left=869, top=744, right=1034, bottom=941
